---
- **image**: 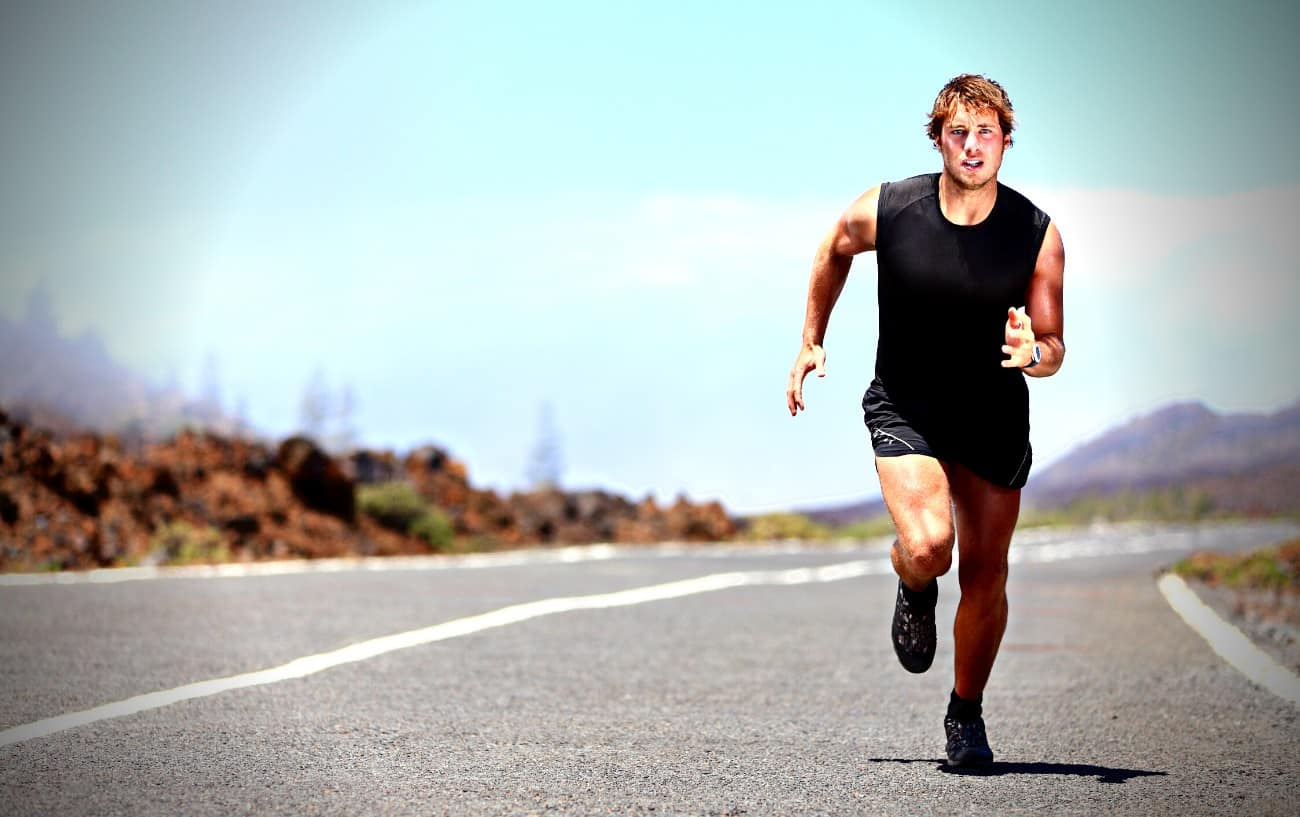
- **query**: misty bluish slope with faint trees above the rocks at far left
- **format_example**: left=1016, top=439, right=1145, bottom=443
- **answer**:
left=0, top=288, right=239, bottom=437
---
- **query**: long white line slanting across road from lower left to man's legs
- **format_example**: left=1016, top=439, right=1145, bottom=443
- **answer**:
left=0, top=558, right=893, bottom=747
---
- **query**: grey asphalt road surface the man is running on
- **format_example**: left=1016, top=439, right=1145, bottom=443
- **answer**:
left=0, top=526, right=1300, bottom=817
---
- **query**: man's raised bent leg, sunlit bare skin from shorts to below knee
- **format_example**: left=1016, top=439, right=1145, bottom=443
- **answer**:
left=876, top=454, right=953, bottom=592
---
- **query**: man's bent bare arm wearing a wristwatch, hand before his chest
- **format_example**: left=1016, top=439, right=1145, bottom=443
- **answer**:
left=1002, top=222, right=1065, bottom=377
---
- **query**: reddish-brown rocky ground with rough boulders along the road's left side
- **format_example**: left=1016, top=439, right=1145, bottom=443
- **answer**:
left=0, top=410, right=736, bottom=571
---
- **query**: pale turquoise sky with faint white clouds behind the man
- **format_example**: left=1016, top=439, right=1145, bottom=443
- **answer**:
left=0, top=0, right=1300, bottom=511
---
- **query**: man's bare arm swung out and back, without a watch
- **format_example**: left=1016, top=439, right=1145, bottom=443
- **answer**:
left=785, top=186, right=880, bottom=416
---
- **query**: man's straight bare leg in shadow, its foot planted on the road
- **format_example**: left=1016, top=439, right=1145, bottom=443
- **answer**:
left=946, top=464, right=1021, bottom=700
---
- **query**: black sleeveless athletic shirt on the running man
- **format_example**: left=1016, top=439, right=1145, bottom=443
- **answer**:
left=876, top=173, right=1049, bottom=426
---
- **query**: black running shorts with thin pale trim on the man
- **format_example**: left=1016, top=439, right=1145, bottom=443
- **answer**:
left=862, top=379, right=1034, bottom=488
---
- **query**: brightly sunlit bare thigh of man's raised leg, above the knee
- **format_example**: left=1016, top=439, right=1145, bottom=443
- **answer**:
left=876, top=454, right=953, bottom=545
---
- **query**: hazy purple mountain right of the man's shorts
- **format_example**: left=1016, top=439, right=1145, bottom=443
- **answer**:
left=1026, top=402, right=1300, bottom=505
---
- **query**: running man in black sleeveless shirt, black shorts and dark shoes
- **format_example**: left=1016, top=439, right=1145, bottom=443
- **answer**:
left=785, top=74, right=1065, bottom=764
